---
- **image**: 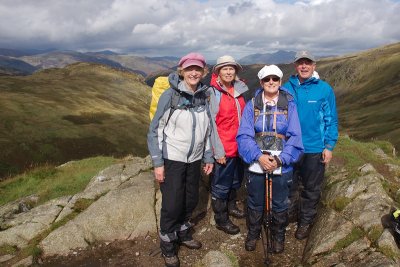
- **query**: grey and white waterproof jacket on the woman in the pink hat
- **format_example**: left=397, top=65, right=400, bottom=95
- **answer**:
left=147, top=72, right=214, bottom=167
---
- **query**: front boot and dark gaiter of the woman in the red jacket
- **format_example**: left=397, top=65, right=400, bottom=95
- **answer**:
left=211, top=197, right=240, bottom=235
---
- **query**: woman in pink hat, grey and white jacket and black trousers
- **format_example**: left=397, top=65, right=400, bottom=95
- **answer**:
left=147, top=53, right=214, bottom=266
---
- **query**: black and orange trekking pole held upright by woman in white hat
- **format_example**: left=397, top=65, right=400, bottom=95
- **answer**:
left=261, top=172, right=273, bottom=266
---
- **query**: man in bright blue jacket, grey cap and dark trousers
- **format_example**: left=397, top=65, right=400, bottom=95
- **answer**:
left=284, top=51, right=338, bottom=240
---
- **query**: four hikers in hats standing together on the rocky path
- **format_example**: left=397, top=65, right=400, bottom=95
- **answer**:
left=147, top=51, right=338, bottom=266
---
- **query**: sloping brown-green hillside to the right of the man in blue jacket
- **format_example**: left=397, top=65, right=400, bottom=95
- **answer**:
left=317, top=43, right=400, bottom=149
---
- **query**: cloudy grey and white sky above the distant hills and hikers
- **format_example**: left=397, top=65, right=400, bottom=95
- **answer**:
left=0, top=0, right=400, bottom=59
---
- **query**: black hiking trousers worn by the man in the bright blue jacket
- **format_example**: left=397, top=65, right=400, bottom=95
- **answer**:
left=289, top=153, right=325, bottom=225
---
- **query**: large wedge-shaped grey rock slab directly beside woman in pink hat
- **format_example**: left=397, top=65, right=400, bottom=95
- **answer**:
left=40, top=173, right=157, bottom=256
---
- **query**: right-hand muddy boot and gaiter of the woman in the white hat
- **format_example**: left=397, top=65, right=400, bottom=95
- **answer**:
left=272, top=210, right=289, bottom=253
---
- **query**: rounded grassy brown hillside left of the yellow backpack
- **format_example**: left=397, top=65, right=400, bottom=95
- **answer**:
left=0, top=63, right=150, bottom=177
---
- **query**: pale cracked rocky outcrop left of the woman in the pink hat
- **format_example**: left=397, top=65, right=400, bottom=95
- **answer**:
left=0, top=157, right=157, bottom=262
